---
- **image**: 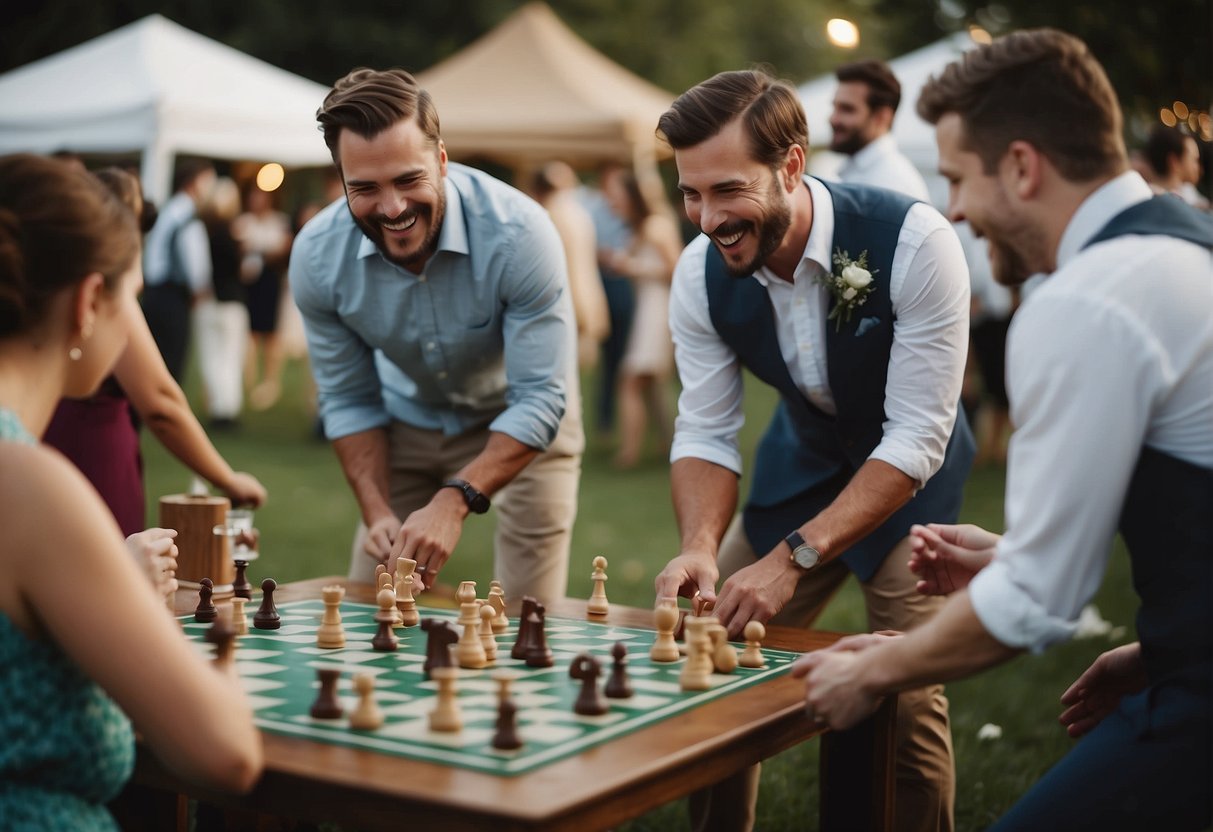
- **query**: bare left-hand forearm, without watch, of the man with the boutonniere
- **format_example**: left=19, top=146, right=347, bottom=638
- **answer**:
left=670, top=457, right=738, bottom=557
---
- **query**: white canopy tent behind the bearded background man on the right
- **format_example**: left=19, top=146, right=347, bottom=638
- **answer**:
left=798, top=32, right=975, bottom=206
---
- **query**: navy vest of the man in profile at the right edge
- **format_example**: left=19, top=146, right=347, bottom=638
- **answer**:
left=1087, top=195, right=1213, bottom=688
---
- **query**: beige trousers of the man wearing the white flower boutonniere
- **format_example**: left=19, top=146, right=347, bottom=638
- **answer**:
left=690, top=515, right=956, bottom=832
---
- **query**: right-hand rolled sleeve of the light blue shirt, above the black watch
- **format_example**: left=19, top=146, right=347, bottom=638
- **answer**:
left=489, top=209, right=576, bottom=450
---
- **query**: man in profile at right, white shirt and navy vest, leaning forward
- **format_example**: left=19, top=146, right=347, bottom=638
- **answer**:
left=795, top=29, right=1213, bottom=832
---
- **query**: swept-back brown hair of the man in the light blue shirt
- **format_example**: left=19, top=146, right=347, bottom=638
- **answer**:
left=315, top=67, right=442, bottom=163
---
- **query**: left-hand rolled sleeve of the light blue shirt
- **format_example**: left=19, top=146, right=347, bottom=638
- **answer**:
left=290, top=235, right=391, bottom=440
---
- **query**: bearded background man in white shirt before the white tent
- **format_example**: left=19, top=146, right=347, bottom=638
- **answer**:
left=830, top=61, right=930, bottom=203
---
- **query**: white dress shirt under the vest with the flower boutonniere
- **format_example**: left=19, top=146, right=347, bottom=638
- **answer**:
left=670, top=176, right=969, bottom=486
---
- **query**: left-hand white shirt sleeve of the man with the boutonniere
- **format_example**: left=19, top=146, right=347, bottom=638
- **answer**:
left=670, top=237, right=745, bottom=475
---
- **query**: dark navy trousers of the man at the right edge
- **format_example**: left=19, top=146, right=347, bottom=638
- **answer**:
left=991, top=684, right=1213, bottom=832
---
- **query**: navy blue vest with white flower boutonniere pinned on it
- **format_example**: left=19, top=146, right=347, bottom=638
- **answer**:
left=705, top=177, right=974, bottom=581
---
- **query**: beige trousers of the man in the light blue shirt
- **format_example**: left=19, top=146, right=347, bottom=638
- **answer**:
left=349, top=392, right=585, bottom=609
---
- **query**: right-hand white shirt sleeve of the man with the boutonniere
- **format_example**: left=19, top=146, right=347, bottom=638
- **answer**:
left=870, top=204, right=969, bottom=488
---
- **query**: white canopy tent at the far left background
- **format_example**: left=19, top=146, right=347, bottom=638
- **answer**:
left=0, top=15, right=330, bottom=200
